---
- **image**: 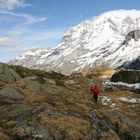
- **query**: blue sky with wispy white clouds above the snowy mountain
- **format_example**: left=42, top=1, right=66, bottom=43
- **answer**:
left=0, top=0, right=140, bottom=62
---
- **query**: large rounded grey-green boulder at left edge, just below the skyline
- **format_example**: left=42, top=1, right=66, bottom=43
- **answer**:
left=0, top=63, right=21, bottom=83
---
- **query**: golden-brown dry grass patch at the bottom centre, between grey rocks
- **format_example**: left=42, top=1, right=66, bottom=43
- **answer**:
left=39, top=115, right=90, bottom=140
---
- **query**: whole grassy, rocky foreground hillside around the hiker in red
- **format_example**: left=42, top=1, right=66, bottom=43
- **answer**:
left=0, top=63, right=140, bottom=140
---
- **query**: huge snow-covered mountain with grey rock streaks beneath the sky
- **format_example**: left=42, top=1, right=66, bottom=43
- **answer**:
left=10, top=10, right=140, bottom=74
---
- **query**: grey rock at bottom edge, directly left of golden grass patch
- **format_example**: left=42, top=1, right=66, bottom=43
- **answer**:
left=16, top=118, right=64, bottom=140
